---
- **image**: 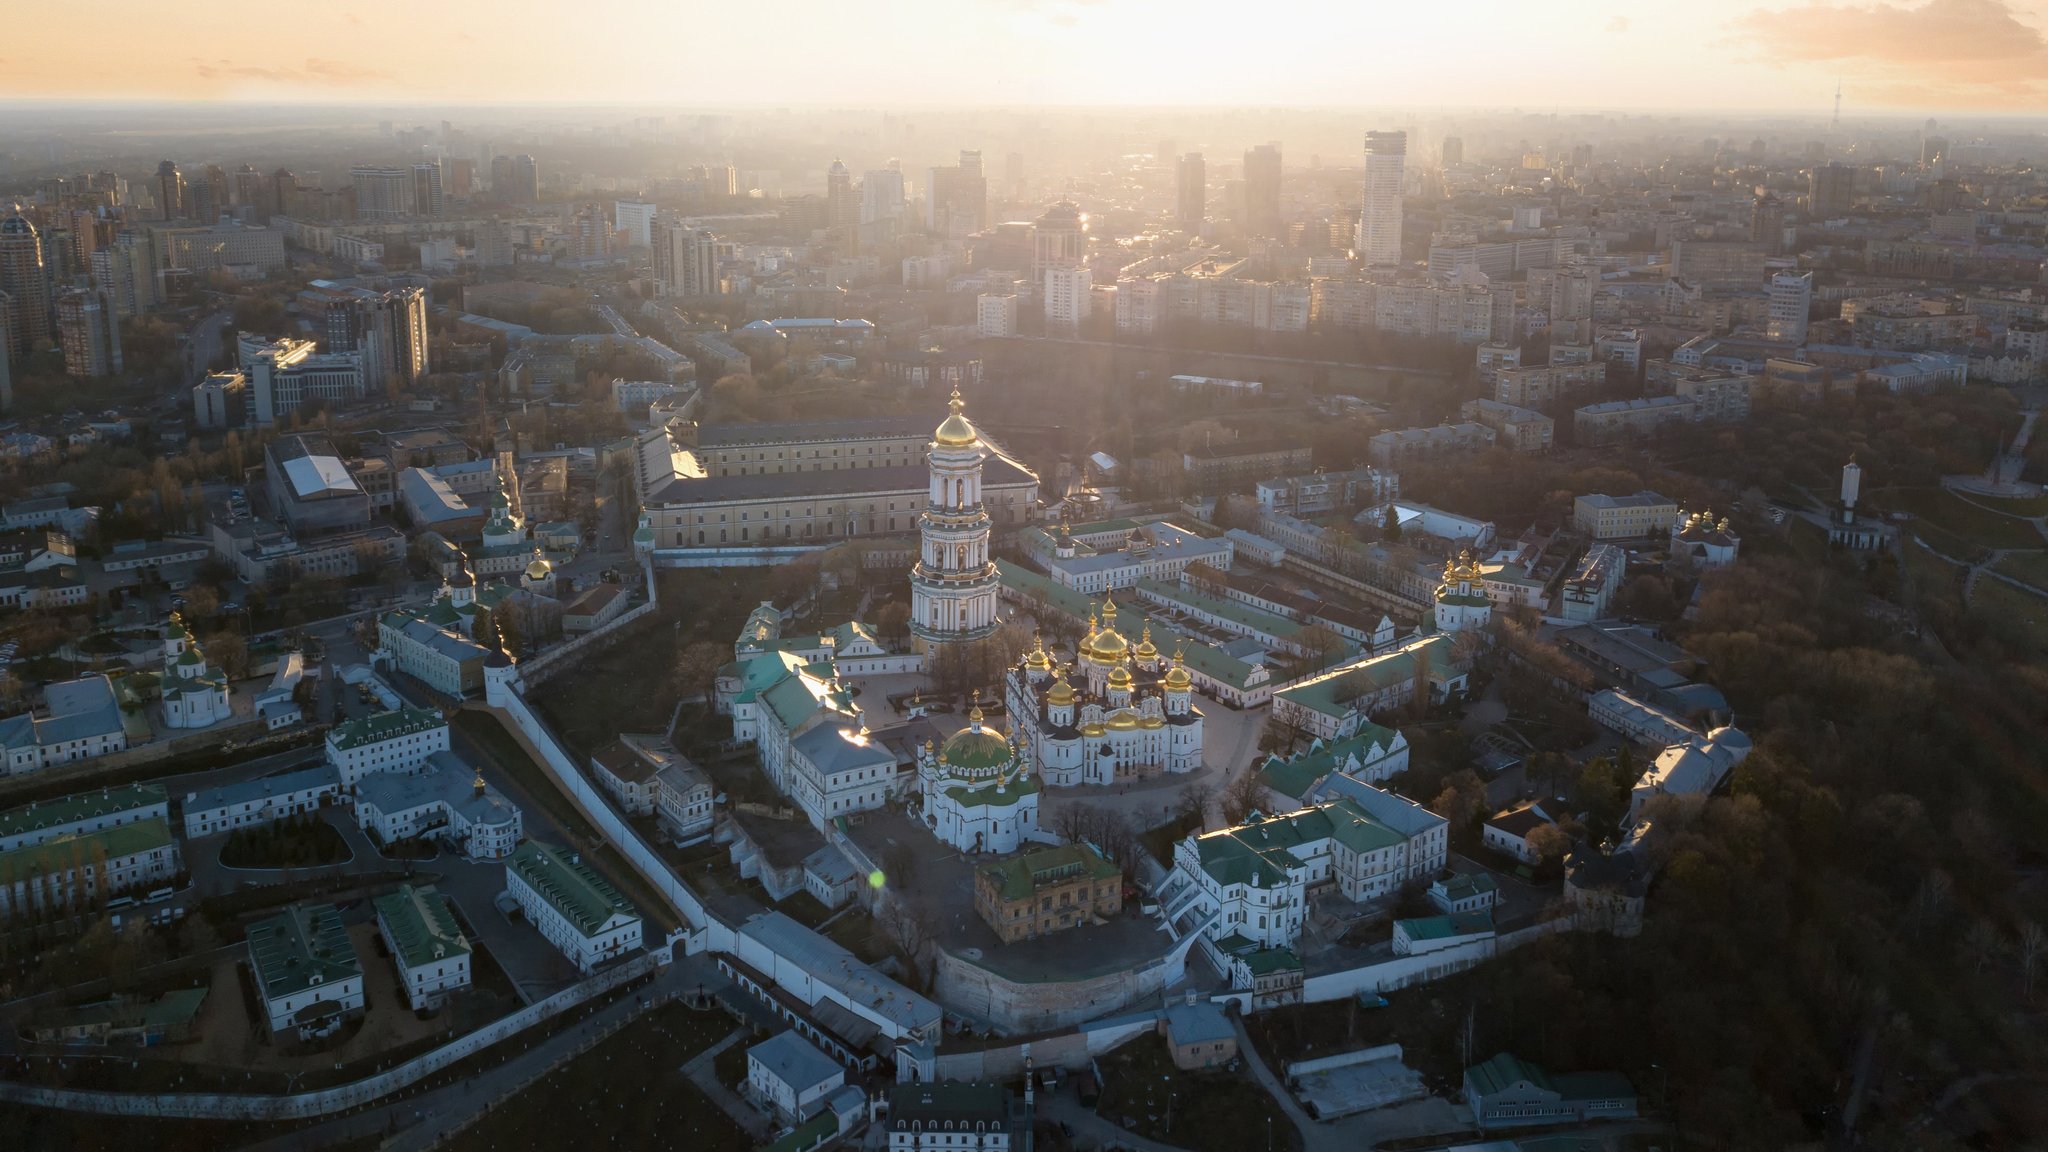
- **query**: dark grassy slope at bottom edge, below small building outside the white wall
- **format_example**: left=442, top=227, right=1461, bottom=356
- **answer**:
left=1096, top=1035, right=1300, bottom=1152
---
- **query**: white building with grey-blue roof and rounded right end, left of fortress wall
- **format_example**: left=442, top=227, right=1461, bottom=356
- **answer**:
left=356, top=752, right=524, bottom=861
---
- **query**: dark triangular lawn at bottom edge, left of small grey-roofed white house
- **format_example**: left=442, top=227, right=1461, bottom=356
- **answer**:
left=446, top=1004, right=754, bottom=1152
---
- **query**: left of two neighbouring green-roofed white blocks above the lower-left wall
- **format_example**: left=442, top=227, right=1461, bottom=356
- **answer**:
left=248, top=904, right=362, bottom=1039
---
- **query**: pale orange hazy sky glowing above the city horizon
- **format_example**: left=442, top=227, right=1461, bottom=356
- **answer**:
left=12, top=0, right=2048, bottom=115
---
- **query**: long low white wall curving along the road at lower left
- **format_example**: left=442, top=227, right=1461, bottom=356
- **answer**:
left=0, top=951, right=668, bottom=1121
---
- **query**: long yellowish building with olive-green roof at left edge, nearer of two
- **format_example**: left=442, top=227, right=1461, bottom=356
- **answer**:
left=0, top=816, right=178, bottom=920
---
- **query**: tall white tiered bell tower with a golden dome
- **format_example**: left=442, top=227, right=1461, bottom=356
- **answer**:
left=909, top=389, right=999, bottom=650
